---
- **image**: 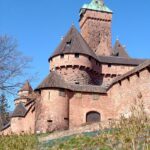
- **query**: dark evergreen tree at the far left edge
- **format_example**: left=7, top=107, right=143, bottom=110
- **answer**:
left=0, top=93, right=9, bottom=128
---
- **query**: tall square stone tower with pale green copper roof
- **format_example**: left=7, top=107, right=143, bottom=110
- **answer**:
left=79, top=0, right=112, bottom=56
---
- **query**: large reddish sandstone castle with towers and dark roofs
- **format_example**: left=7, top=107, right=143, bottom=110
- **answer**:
left=1, top=0, right=150, bottom=135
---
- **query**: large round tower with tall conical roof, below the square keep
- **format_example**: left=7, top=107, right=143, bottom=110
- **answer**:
left=49, top=26, right=101, bottom=85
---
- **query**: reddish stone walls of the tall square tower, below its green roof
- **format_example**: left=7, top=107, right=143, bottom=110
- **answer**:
left=80, top=10, right=112, bottom=56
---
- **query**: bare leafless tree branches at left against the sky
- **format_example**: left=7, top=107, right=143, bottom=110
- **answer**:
left=0, top=36, right=30, bottom=94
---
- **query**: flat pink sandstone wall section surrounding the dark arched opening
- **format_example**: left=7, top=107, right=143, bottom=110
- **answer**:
left=69, top=93, right=113, bottom=128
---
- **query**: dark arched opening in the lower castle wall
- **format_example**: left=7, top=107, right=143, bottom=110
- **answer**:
left=86, top=111, right=101, bottom=123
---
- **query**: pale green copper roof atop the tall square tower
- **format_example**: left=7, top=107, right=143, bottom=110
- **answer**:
left=80, top=0, right=112, bottom=14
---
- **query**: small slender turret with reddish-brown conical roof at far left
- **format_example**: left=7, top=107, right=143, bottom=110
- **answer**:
left=15, top=81, right=33, bottom=105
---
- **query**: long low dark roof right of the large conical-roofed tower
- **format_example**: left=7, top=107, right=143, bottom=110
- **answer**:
left=98, top=56, right=146, bottom=66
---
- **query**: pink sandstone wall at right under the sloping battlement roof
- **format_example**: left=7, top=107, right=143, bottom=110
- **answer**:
left=109, top=69, right=150, bottom=118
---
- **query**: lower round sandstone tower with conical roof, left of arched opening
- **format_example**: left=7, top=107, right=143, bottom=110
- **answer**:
left=35, top=71, right=69, bottom=133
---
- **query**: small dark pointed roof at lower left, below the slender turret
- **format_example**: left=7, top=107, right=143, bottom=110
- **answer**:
left=11, top=103, right=27, bottom=117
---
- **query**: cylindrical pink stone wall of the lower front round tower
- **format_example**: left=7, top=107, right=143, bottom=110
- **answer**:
left=36, top=90, right=69, bottom=132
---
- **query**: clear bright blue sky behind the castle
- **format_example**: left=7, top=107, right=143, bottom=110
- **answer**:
left=0, top=0, right=150, bottom=107
